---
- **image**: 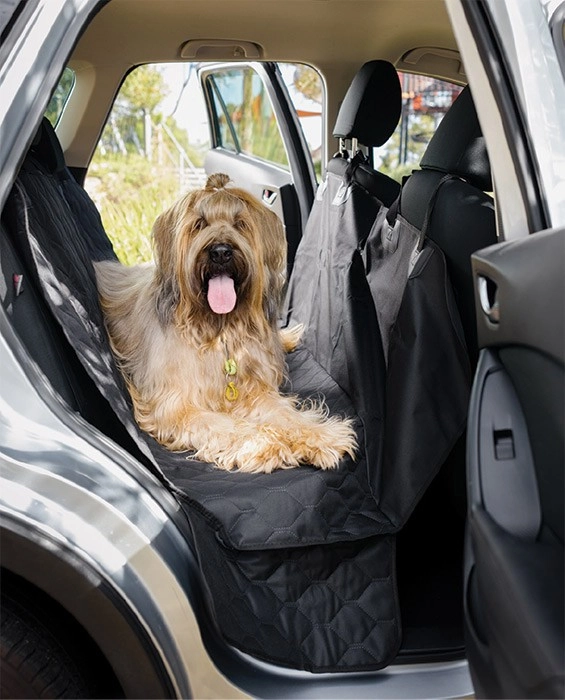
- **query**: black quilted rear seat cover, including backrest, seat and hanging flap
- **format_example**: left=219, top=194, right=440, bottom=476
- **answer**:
left=5, top=149, right=400, bottom=671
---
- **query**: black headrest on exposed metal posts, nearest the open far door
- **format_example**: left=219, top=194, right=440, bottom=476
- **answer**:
left=333, top=61, right=402, bottom=146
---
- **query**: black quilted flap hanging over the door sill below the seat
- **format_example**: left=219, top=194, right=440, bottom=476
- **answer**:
left=191, top=514, right=400, bottom=672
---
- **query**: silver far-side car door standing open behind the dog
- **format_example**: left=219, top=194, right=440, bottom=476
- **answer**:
left=199, top=63, right=316, bottom=267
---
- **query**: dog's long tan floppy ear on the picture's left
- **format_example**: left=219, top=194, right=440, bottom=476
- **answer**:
left=152, top=198, right=180, bottom=325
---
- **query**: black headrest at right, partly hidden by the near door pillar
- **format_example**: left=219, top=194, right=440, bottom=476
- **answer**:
left=420, top=87, right=492, bottom=192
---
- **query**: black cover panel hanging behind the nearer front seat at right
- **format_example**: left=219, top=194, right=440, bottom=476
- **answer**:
left=363, top=215, right=471, bottom=524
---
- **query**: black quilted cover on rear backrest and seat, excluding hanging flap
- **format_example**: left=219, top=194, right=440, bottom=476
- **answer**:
left=15, top=169, right=391, bottom=549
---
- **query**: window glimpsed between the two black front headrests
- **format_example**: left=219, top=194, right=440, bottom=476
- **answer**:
left=373, top=72, right=463, bottom=181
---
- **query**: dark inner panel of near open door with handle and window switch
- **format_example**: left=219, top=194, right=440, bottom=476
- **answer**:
left=465, top=230, right=565, bottom=697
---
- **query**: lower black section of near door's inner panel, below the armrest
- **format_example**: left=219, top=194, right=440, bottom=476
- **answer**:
left=470, top=509, right=564, bottom=698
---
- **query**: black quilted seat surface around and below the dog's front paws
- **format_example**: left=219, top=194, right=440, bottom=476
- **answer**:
left=161, top=350, right=391, bottom=549
